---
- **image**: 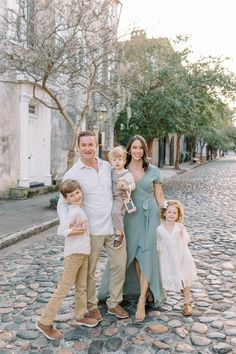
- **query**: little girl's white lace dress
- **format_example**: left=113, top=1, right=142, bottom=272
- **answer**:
left=157, top=222, right=197, bottom=291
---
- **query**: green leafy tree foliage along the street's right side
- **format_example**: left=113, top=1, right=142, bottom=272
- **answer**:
left=116, top=34, right=236, bottom=148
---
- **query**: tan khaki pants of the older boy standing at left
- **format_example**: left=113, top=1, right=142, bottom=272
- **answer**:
left=39, top=253, right=88, bottom=326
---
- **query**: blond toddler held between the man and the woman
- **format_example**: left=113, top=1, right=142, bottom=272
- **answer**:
left=108, top=146, right=136, bottom=249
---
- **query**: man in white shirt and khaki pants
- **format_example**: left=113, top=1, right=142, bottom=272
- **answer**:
left=57, top=131, right=129, bottom=321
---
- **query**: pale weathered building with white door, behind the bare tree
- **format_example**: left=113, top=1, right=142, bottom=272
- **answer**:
left=0, top=0, right=120, bottom=197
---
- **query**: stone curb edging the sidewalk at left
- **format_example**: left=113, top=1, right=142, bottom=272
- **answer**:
left=0, top=217, right=59, bottom=250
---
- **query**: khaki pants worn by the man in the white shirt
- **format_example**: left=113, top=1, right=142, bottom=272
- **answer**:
left=88, top=235, right=127, bottom=310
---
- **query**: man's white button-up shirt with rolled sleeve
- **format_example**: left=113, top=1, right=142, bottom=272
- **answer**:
left=57, top=158, right=114, bottom=236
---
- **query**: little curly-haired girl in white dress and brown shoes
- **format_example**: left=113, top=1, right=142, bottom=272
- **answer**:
left=157, top=200, right=197, bottom=316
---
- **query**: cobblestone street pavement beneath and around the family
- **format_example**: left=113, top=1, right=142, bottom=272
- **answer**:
left=0, top=157, right=236, bottom=354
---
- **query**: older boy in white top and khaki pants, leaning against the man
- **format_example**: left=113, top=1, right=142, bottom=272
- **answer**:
left=36, top=179, right=98, bottom=339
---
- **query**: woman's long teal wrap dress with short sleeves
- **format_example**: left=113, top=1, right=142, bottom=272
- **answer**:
left=98, top=165, right=165, bottom=305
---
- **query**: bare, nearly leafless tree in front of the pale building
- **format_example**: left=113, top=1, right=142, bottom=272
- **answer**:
left=0, top=0, right=118, bottom=167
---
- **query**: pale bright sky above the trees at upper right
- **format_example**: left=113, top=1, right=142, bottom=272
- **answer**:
left=119, top=0, right=236, bottom=74
